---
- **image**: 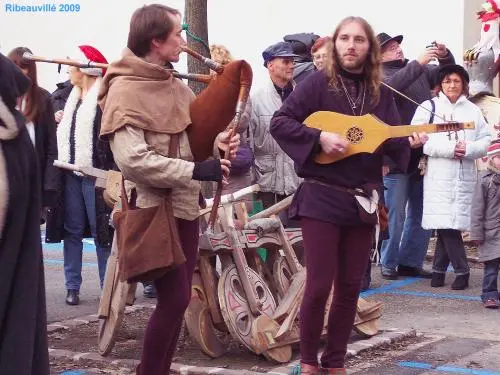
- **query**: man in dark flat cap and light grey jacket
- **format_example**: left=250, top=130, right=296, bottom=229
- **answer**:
left=250, top=42, right=299, bottom=225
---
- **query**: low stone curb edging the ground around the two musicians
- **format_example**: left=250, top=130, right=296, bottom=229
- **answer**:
left=49, top=322, right=417, bottom=375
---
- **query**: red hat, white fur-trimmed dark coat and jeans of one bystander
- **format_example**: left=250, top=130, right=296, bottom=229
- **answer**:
left=46, top=46, right=114, bottom=305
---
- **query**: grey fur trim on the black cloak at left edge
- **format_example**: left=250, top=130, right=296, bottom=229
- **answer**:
left=0, top=97, right=19, bottom=240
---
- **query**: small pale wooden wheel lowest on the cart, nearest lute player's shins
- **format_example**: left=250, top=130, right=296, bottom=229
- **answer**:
left=252, top=315, right=292, bottom=363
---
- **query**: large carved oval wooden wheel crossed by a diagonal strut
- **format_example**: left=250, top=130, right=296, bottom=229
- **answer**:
left=218, top=265, right=276, bottom=353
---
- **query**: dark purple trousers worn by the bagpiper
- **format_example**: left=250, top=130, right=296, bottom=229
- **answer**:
left=137, top=219, right=199, bottom=375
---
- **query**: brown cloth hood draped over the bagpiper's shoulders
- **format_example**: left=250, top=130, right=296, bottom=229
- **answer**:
left=98, top=48, right=195, bottom=138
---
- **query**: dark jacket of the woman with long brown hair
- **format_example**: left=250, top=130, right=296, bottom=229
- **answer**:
left=34, top=88, right=59, bottom=207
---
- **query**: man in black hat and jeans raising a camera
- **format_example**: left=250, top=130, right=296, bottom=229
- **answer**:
left=377, top=33, right=455, bottom=280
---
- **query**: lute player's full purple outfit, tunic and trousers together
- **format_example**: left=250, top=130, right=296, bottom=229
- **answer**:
left=271, top=70, right=410, bottom=369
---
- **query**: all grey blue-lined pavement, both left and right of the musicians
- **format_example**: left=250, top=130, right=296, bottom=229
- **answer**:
left=43, top=234, right=500, bottom=375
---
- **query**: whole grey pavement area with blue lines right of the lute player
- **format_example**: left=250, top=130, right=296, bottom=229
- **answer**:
left=342, top=266, right=500, bottom=375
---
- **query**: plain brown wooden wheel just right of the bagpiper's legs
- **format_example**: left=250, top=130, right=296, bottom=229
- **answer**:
left=184, top=272, right=226, bottom=358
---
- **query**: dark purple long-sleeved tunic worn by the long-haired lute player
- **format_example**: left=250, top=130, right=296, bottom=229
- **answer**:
left=270, top=71, right=410, bottom=225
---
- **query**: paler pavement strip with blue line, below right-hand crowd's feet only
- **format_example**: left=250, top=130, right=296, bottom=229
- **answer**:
left=362, top=266, right=500, bottom=344
